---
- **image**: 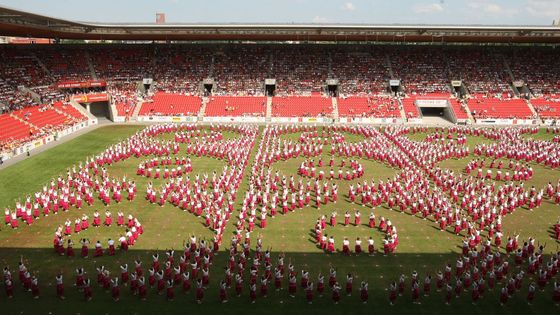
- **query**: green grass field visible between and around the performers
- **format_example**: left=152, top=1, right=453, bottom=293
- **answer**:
left=0, top=126, right=560, bottom=315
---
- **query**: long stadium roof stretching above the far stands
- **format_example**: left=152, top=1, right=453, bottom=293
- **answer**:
left=0, top=7, right=560, bottom=43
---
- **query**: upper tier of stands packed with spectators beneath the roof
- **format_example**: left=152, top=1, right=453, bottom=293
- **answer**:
left=0, top=44, right=560, bottom=99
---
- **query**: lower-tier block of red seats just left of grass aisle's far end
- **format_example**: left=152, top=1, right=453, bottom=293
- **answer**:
left=204, top=96, right=266, bottom=117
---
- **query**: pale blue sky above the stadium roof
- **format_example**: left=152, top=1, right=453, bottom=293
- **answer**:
left=0, top=0, right=560, bottom=25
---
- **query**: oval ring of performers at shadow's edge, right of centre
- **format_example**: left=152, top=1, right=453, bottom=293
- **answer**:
left=315, top=211, right=399, bottom=256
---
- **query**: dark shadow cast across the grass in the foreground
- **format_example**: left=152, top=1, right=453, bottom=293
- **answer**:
left=0, top=248, right=558, bottom=314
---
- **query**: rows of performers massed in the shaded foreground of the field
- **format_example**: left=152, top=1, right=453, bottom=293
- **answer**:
left=3, top=235, right=560, bottom=305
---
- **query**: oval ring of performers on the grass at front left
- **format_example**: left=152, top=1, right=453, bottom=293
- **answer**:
left=53, top=210, right=144, bottom=258
